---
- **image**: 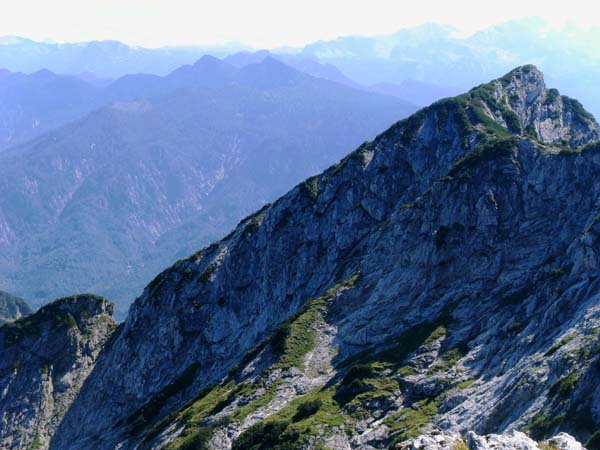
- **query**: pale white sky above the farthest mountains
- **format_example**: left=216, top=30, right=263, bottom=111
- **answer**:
left=0, top=0, right=600, bottom=48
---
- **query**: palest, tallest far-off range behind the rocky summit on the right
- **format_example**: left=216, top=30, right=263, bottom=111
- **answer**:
left=301, top=18, right=600, bottom=115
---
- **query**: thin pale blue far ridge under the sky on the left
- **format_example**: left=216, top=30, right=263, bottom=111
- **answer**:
left=0, top=36, right=245, bottom=78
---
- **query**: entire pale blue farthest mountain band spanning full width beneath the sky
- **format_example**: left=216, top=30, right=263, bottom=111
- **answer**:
left=0, top=17, right=600, bottom=115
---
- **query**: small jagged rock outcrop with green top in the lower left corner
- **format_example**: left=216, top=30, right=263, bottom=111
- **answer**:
left=0, top=295, right=115, bottom=450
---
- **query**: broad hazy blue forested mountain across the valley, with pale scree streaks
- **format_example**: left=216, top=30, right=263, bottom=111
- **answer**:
left=0, top=58, right=415, bottom=313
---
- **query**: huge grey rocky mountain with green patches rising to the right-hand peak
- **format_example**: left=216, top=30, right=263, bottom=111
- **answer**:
left=1, top=66, right=600, bottom=450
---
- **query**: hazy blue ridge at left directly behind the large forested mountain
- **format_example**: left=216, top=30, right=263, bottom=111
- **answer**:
left=0, top=52, right=366, bottom=151
